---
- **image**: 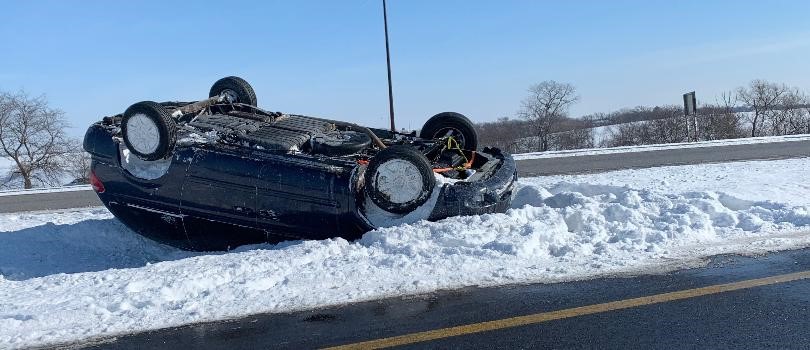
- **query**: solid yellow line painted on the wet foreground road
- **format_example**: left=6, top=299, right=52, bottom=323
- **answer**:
left=327, top=271, right=810, bottom=350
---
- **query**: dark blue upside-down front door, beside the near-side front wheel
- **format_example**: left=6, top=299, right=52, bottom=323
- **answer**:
left=256, top=154, right=341, bottom=239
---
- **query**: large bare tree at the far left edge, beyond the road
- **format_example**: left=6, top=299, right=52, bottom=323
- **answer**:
left=0, top=92, right=72, bottom=188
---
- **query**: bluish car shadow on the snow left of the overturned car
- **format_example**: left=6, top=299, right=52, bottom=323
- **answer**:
left=0, top=219, right=200, bottom=281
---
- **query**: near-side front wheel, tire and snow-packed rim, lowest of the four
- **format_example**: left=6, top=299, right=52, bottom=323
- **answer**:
left=364, top=145, right=436, bottom=214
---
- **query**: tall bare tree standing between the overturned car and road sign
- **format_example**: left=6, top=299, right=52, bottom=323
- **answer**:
left=519, top=80, right=579, bottom=151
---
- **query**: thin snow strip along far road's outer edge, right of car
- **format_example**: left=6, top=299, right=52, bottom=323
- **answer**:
left=512, top=135, right=810, bottom=160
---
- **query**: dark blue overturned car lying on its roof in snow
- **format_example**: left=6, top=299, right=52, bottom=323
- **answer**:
left=84, top=77, right=517, bottom=250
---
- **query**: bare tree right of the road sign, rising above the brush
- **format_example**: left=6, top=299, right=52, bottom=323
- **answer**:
left=737, top=79, right=788, bottom=137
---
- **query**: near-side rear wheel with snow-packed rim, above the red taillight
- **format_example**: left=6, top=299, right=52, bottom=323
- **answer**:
left=121, top=101, right=177, bottom=161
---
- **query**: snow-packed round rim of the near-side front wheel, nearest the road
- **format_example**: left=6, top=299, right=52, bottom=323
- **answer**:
left=374, top=159, right=423, bottom=204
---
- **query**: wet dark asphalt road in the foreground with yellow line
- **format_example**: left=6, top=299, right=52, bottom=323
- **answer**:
left=79, top=249, right=810, bottom=350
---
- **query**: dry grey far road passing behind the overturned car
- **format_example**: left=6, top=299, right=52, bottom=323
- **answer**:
left=0, top=141, right=810, bottom=213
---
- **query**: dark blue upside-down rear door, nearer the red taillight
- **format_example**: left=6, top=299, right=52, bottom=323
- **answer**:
left=181, top=145, right=261, bottom=228
